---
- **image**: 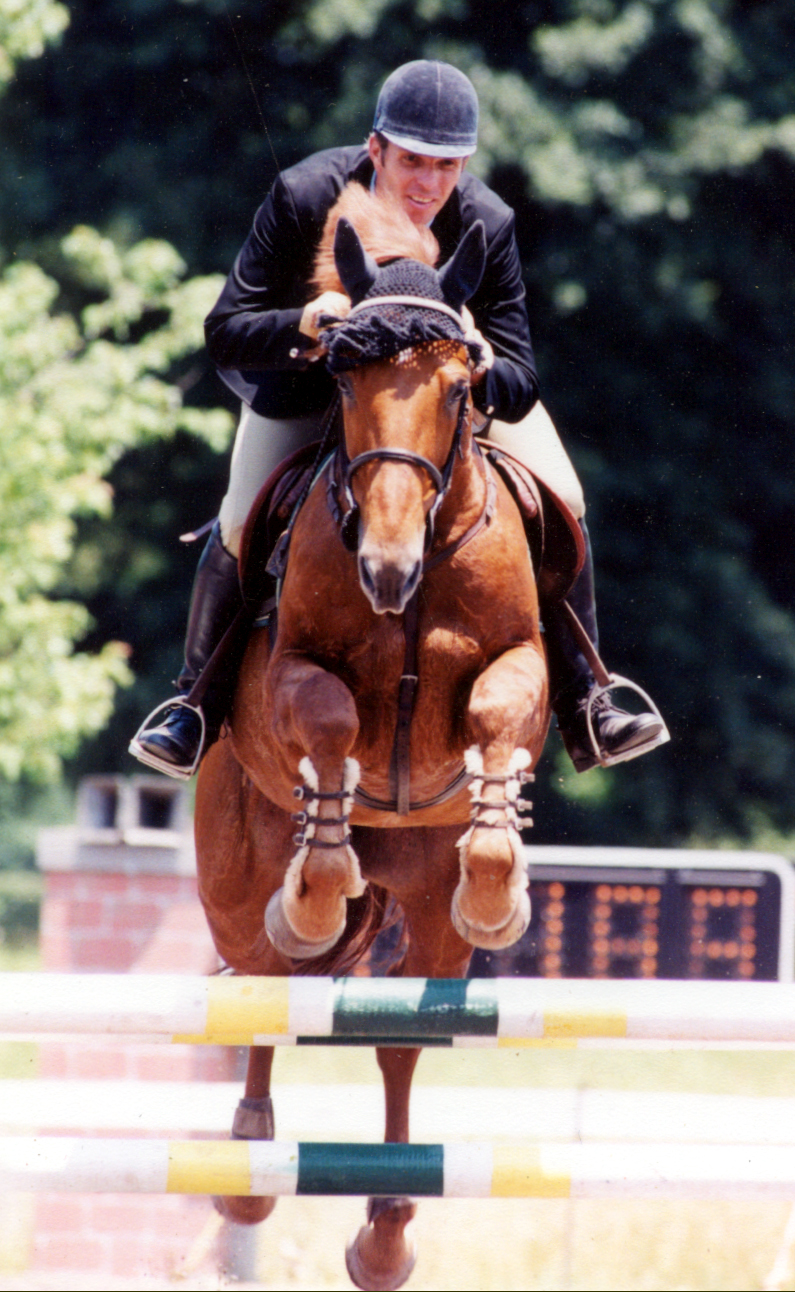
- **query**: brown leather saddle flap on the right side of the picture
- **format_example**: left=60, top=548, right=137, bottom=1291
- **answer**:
left=482, top=441, right=586, bottom=601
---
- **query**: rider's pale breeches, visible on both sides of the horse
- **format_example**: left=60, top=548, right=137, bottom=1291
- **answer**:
left=218, top=403, right=586, bottom=557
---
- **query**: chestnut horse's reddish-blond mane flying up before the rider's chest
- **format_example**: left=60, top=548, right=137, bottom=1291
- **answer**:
left=310, top=181, right=440, bottom=295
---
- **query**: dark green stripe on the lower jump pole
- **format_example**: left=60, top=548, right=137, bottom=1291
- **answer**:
left=296, top=1143, right=445, bottom=1198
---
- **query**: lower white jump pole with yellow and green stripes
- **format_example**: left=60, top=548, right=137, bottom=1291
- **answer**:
left=0, top=1137, right=795, bottom=1199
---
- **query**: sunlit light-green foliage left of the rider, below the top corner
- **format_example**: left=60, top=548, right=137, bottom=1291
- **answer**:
left=0, top=227, right=229, bottom=779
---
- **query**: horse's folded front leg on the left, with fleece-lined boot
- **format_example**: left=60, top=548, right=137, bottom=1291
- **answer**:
left=265, top=655, right=365, bottom=960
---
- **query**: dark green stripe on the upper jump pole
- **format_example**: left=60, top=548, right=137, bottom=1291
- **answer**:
left=332, top=978, right=499, bottom=1040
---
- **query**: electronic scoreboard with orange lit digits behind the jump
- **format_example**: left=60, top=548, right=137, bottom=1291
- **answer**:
left=469, top=846, right=795, bottom=982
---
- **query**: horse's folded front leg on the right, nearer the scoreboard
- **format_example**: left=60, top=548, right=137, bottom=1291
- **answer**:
left=451, top=646, right=548, bottom=948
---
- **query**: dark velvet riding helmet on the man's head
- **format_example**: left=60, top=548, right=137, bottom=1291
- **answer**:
left=372, top=59, right=477, bottom=158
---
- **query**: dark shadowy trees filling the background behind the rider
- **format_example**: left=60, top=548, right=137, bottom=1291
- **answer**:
left=0, top=0, right=795, bottom=845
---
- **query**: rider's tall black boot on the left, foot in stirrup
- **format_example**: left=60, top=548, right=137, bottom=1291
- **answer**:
left=129, top=521, right=243, bottom=780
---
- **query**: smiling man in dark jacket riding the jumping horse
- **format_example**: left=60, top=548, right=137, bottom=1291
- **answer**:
left=131, top=61, right=667, bottom=776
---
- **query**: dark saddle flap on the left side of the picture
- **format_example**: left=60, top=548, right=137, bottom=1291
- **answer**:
left=239, top=441, right=319, bottom=605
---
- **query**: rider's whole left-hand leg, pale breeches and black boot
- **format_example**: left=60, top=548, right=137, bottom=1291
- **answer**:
left=129, top=406, right=317, bottom=776
